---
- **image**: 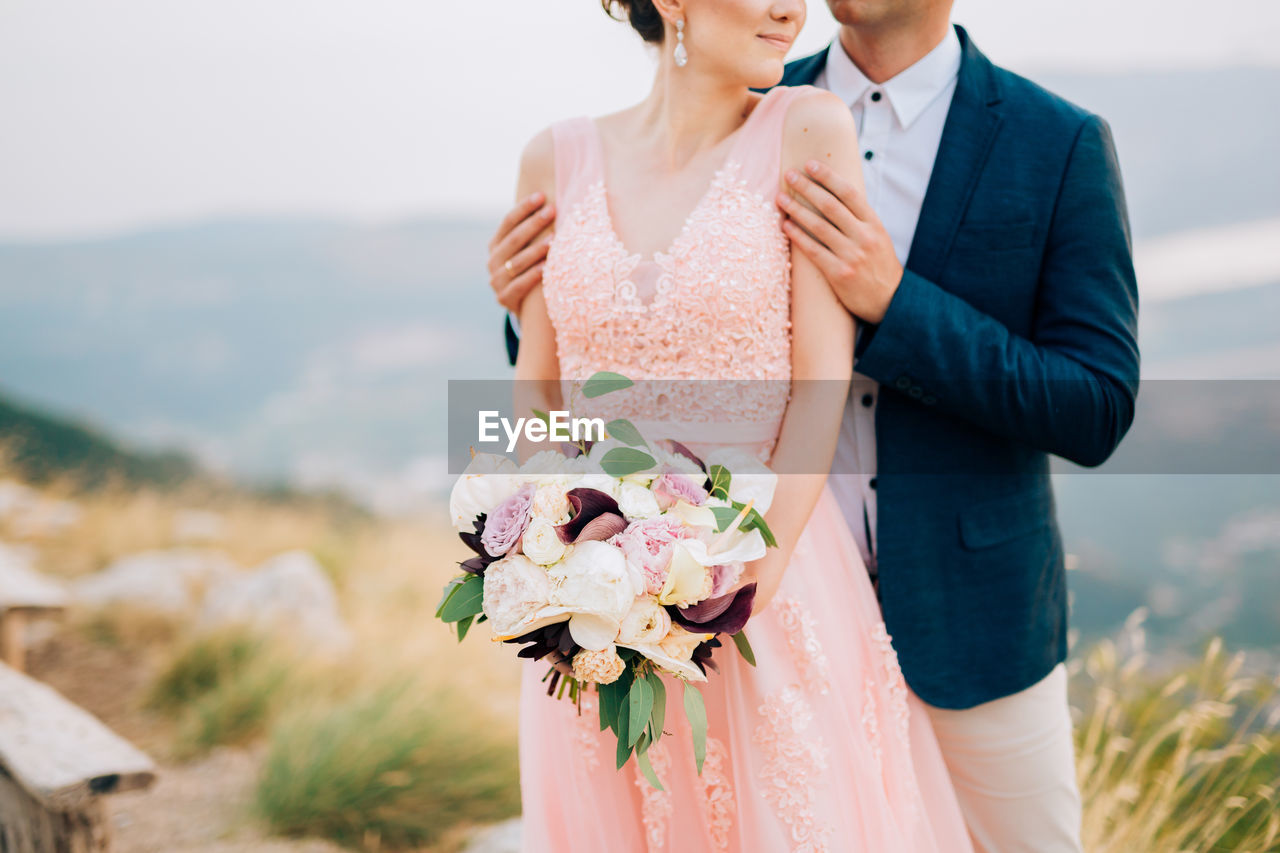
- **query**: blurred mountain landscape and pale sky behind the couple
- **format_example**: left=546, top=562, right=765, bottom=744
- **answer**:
left=0, top=0, right=1280, bottom=850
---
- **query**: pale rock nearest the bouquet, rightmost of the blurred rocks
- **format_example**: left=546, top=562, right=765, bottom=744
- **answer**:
left=196, top=549, right=352, bottom=652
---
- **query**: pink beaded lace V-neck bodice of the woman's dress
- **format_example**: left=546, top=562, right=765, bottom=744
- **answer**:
left=543, top=87, right=800, bottom=459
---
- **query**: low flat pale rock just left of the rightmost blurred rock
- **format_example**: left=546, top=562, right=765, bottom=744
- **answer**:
left=72, top=548, right=238, bottom=615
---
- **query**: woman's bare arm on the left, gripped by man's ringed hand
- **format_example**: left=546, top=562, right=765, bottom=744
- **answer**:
left=512, top=129, right=563, bottom=461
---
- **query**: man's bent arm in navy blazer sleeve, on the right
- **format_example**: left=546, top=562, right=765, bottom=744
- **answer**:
left=778, top=115, right=1139, bottom=466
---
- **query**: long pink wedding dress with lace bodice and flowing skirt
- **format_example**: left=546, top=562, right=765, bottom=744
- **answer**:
left=520, top=87, right=972, bottom=853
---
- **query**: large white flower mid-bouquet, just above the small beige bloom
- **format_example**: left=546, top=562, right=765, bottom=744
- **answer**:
left=547, top=542, right=643, bottom=652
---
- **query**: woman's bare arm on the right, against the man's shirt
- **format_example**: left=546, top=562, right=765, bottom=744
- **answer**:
left=748, top=90, right=863, bottom=613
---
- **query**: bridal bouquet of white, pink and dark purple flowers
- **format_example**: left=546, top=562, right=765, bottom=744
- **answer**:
left=435, top=378, right=777, bottom=788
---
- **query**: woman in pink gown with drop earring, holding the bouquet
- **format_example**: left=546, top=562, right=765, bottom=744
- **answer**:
left=504, top=0, right=972, bottom=853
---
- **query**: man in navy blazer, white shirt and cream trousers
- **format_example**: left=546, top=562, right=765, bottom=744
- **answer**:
left=489, top=0, right=1138, bottom=853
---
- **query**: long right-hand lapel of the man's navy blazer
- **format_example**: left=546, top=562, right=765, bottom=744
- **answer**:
left=906, top=24, right=1001, bottom=280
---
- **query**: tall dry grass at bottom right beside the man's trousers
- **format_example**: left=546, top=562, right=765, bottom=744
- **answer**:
left=1073, top=611, right=1280, bottom=853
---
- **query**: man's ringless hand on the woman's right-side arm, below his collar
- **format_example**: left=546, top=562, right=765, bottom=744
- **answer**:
left=777, top=160, right=902, bottom=323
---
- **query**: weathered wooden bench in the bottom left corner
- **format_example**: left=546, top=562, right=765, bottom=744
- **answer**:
left=0, top=663, right=155, bottom=853
